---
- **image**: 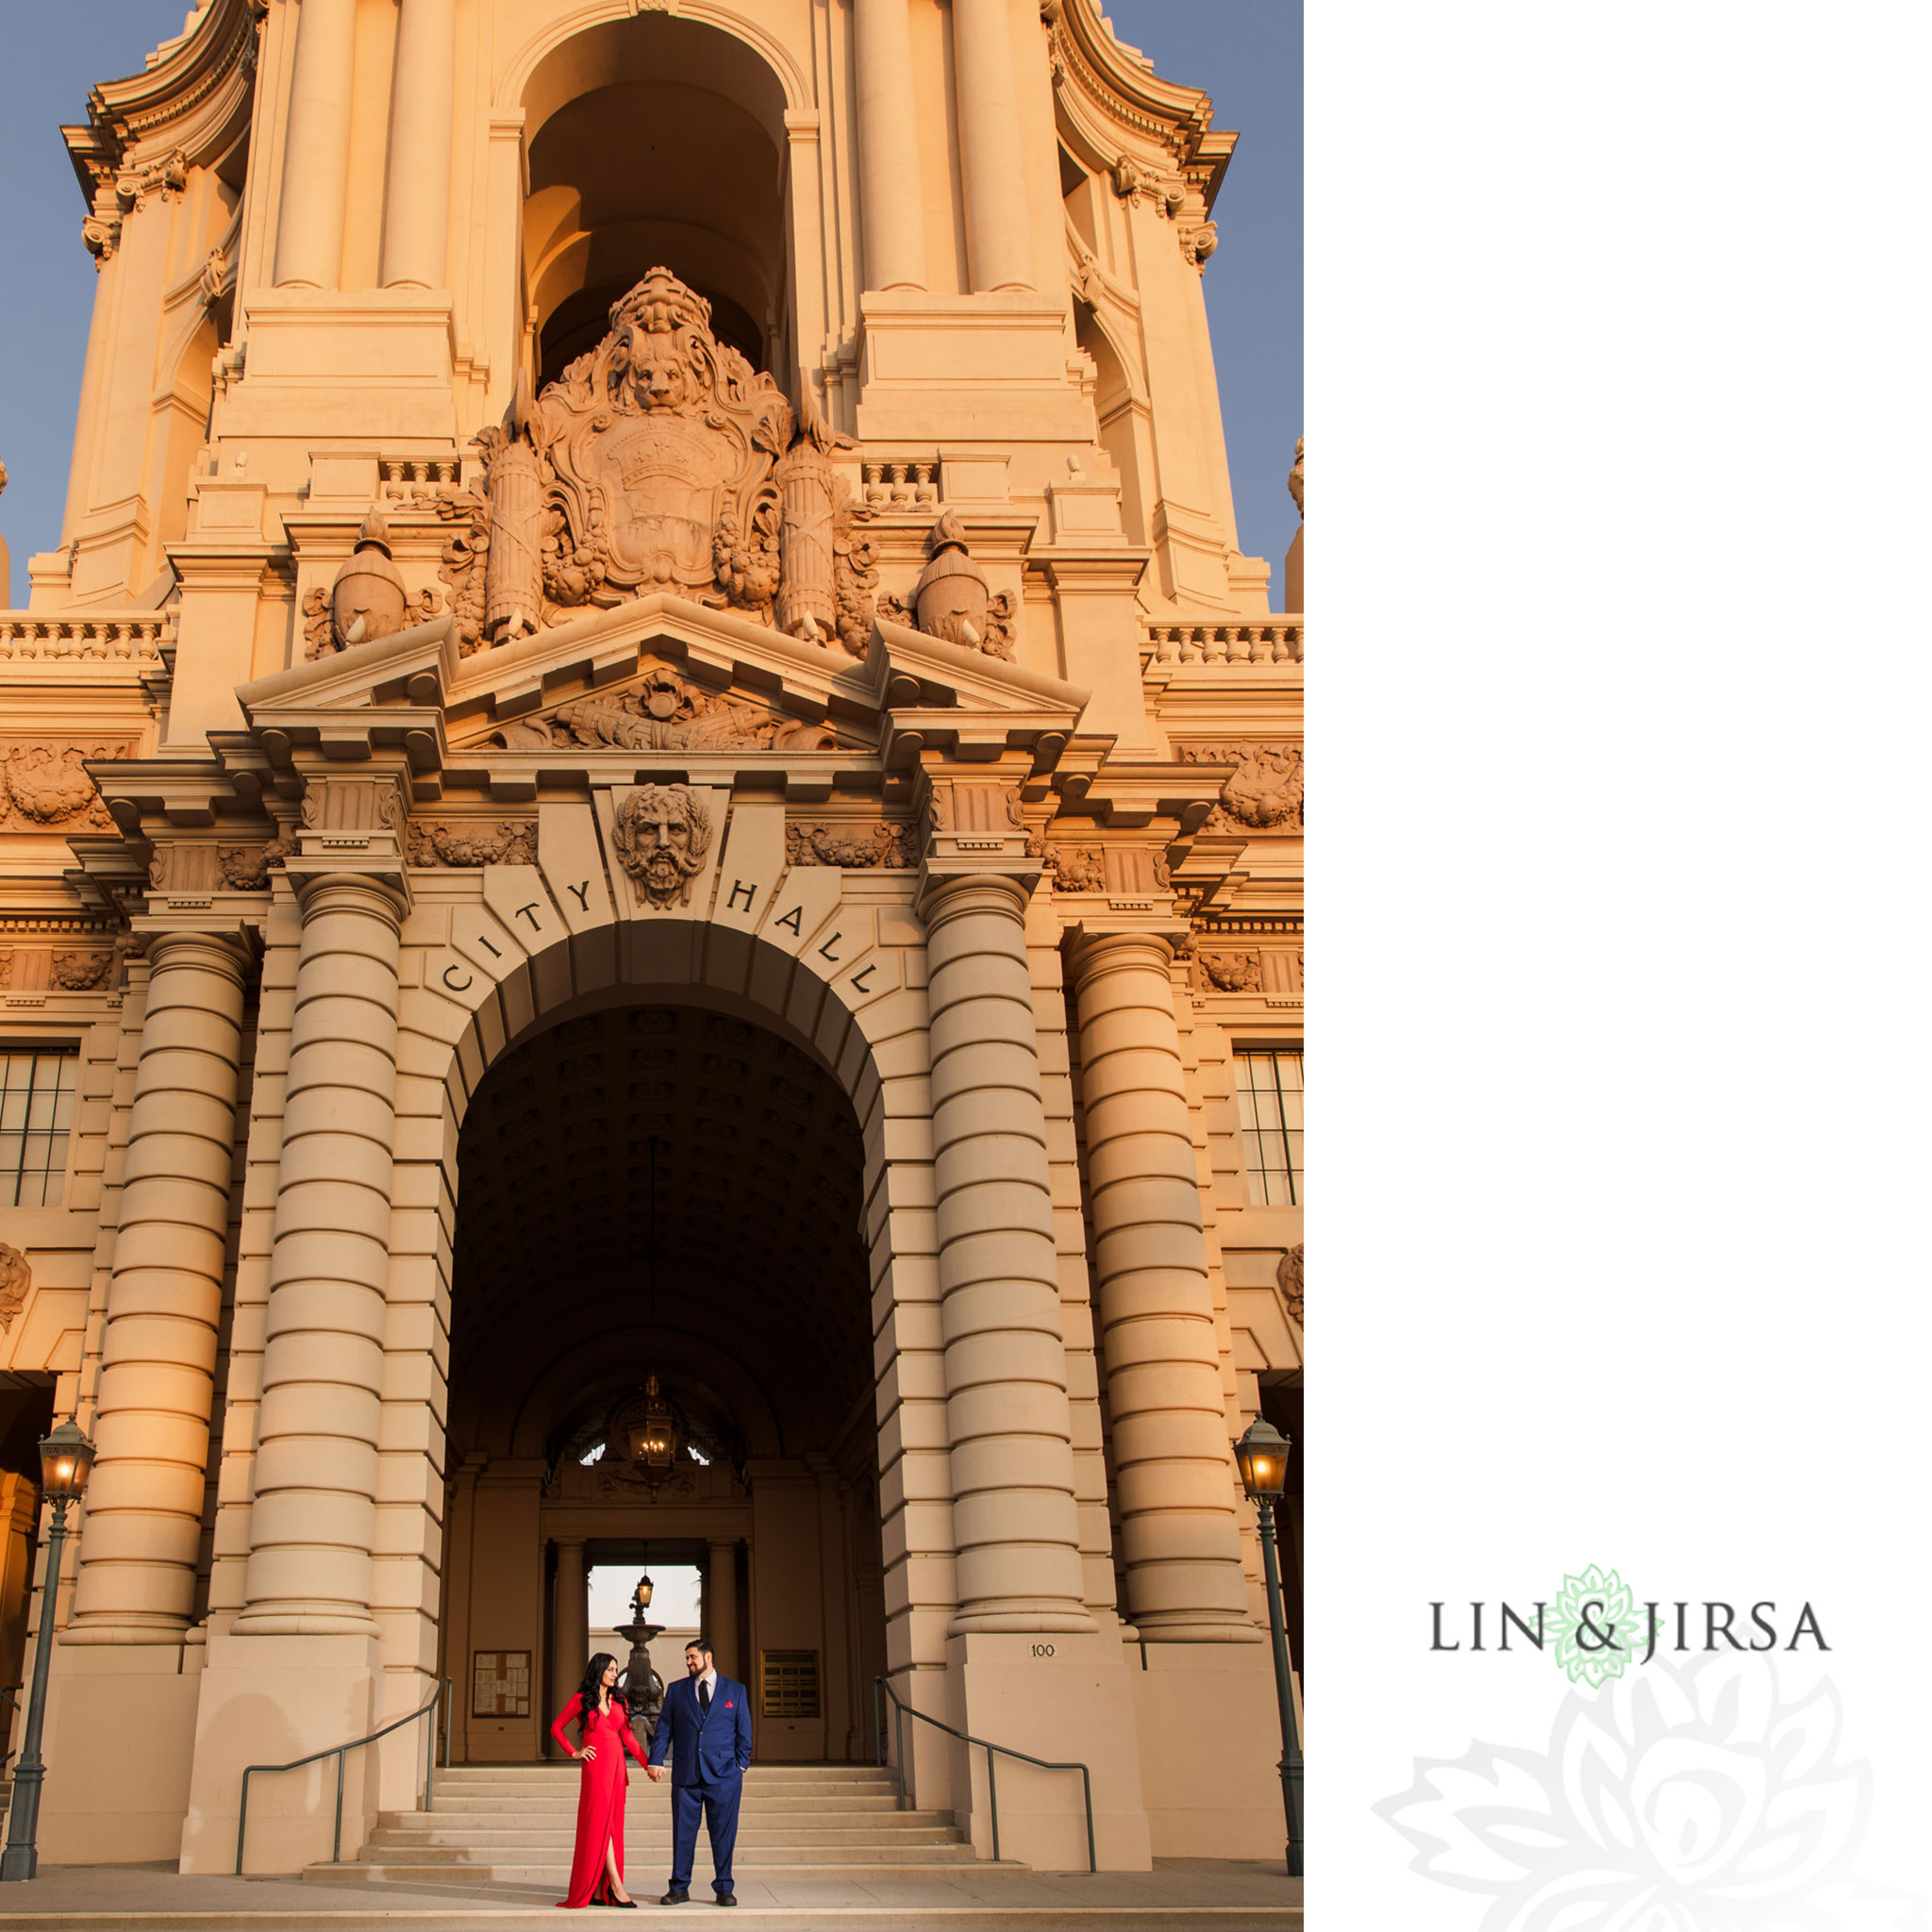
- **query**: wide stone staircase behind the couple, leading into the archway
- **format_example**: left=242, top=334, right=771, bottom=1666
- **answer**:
left=304, top=1764, right=983, bottom=1897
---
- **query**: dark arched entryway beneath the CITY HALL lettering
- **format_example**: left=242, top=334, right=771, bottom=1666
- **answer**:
left=441, top=991, right=885, bottom=1762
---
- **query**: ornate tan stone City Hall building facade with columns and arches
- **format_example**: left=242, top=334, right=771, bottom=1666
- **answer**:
left=0, top=0, right=1302, bottom=1873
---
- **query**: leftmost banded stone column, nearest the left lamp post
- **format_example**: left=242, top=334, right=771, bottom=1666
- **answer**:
left=66, top=933, right=243, bottom=1644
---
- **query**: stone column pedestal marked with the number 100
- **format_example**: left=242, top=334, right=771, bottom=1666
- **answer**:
left=946, top=1619, right=1151, bottom=1873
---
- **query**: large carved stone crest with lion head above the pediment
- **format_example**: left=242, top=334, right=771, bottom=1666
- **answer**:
left=439, top=269, right=892, bottom=651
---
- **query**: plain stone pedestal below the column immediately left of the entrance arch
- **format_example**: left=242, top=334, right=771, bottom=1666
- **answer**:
left=179, top=1631, right=383, bottom=1873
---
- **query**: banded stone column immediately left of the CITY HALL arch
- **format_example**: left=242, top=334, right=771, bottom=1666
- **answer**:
left=236, top=874, right=402, bottom=1635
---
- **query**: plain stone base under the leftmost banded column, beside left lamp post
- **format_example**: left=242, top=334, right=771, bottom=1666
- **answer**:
left=35, top=1637, right=201, bottom=1864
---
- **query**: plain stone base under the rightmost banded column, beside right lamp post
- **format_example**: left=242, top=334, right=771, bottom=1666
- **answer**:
left=1126, top=1624, right=1287, bottom=1862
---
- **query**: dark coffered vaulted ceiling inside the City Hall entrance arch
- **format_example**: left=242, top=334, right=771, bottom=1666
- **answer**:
left=450, top=1005, right=872, bottom=1455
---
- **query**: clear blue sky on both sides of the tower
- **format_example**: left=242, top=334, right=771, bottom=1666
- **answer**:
left=0, top=0, right=1302, bottom=603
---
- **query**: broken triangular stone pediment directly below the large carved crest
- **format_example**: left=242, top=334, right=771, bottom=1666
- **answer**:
left=238, top=593, right=1088, bottom=771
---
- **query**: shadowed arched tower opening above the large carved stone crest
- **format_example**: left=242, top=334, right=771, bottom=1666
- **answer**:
left=524, top=13, right=796, bottom=391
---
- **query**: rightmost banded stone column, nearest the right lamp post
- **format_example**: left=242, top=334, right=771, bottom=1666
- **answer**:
left=1073, top=933, right=1259, bottom=1642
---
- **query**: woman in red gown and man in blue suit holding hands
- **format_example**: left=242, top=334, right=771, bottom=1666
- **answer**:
left=551, top=1637, right=752, bottom=1907
